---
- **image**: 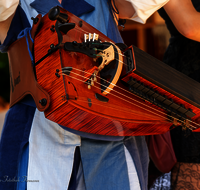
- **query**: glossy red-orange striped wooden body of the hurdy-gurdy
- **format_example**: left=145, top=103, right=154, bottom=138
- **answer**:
left=34, top=6, right=199, bottom=136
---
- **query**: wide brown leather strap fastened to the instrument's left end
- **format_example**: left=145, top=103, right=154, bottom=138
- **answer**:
left=8, top=15, right=50, bottom=111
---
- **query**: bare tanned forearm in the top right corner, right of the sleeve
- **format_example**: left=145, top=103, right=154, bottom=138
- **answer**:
left=164, top=0, right=200, bottom=42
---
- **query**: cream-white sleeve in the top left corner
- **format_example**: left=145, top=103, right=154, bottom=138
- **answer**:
left=0, top=0, right=19, bottom=22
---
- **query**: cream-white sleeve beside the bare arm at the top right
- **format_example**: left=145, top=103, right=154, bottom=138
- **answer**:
left=126, top=0, right=169, bottom=24
